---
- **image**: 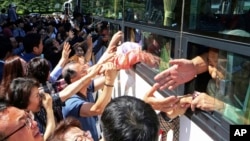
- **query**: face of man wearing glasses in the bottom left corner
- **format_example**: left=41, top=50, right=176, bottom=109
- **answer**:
left=0, top=107, right=43, bottom=141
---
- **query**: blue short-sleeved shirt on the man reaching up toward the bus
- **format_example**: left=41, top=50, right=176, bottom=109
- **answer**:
left=62, top=81, right=99, bottom=141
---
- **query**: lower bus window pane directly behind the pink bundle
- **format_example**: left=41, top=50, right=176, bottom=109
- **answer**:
left=126, top=28, right=174, bottom=72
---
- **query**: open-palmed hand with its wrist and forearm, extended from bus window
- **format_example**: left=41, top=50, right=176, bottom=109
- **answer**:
left=154, top=53, right=208, bottom=90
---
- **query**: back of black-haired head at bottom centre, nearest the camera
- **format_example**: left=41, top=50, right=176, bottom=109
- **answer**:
left=101, top=96, right=160, bottom=141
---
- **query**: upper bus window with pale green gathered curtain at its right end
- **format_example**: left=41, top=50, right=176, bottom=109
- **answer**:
left=86, top=0, right=182, bottom=29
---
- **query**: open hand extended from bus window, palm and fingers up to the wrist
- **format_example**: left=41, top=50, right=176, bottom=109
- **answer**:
left=154, top=59, right=197, bottom=90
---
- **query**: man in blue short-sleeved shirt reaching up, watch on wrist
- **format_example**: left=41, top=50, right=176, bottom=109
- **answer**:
left=62, top=62, right=117, bottom=141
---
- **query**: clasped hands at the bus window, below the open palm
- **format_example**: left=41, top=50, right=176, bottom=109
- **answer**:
left=144, top=85, right=224, bottom=119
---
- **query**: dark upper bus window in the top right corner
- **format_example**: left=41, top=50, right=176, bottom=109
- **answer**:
left=184, top=0, right=250, bottom=42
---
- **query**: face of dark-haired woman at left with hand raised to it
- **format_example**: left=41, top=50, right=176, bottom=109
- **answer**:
left=27, top=87, right=42, bottom=113
